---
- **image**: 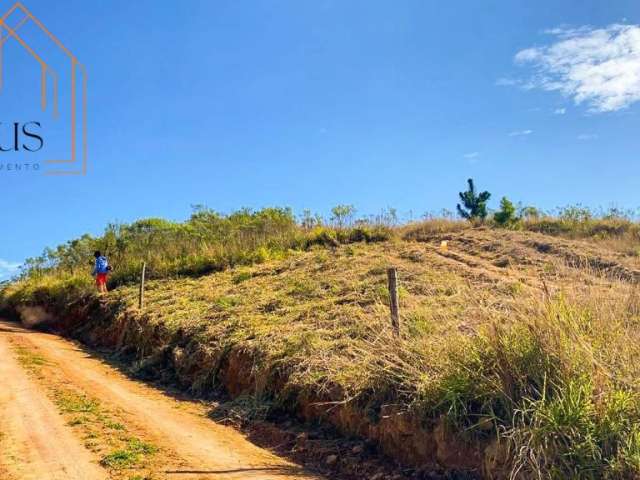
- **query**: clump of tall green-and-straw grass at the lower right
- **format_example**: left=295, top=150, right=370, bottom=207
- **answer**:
left=320, top=278, right=640, bottom=479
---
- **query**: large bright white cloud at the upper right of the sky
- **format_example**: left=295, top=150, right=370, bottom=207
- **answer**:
left=515, top=24, right=640, bottom=112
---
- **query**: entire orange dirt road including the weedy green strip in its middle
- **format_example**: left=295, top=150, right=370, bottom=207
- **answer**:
left=0, top=321, right=319, bottom=480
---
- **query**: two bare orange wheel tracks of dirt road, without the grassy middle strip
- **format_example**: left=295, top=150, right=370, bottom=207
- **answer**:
left=0, top=321, right=320, bottom=480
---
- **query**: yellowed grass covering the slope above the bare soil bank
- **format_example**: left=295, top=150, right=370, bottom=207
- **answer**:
left=3, top=227, right=640, bottom=479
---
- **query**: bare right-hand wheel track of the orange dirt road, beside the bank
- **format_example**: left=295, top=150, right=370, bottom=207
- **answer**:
left=0, top=321, right=320, bottom=480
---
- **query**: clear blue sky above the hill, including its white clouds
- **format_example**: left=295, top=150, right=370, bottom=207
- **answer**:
left=0, top=0, right=640, bottom=277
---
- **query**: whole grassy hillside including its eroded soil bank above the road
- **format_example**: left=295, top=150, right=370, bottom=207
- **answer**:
left=3, top=212, right=640, bottom=478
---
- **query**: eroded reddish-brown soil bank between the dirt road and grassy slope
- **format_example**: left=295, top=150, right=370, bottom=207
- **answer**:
left=17, top=302, right=490, bottom=478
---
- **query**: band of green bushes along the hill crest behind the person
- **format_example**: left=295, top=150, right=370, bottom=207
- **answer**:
left=8, top=206, right=400, bottom=300
